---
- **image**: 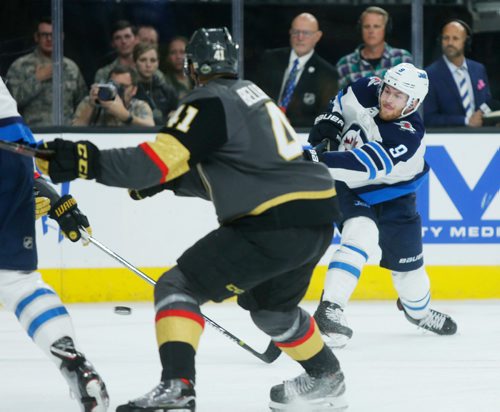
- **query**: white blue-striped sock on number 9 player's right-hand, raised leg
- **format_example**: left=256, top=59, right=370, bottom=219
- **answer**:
left=392, top=266, right=431, bottom=319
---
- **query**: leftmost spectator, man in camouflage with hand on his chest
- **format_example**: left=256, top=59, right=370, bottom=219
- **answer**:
left=6, top=18, right=88, bottom=126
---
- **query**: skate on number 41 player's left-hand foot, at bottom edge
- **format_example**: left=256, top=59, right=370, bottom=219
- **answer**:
left=116, top=379, right=196, bottom=412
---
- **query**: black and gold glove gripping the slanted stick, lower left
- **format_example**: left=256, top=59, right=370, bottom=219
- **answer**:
left=49, top=195, right=92, bottom=246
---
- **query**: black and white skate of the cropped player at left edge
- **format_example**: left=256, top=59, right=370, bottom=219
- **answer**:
left=50, top=336, right=109, bottom=412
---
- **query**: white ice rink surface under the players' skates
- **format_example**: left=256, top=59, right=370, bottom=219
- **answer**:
left=0, top=300, right=500, bottom=412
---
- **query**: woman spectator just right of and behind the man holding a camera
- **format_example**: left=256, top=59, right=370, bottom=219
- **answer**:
left=134, top=43, right=178, bottom=125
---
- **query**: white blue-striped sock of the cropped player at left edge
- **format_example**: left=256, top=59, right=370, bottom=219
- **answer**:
left=0, top=271, right=75, bottom=366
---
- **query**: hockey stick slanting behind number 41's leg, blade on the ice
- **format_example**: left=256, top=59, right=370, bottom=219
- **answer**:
left=80, top=228, right=281, bottom=363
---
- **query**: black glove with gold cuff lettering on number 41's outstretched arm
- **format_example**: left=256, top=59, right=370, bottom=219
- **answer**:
left=36, top=139, right=100, bottom=183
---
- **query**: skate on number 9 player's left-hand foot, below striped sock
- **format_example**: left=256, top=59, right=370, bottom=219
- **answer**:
left=314, top=300, right=352, bottom=348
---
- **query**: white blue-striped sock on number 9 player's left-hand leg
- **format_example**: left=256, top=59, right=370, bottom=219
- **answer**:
left=323, top=244, right=368, bottom=308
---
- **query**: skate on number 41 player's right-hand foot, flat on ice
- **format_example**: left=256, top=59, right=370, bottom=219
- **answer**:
left=269, top=371, right=347, bottom=412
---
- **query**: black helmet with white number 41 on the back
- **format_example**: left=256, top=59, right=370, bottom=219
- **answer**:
left=186, top=27, right=238, bottom=76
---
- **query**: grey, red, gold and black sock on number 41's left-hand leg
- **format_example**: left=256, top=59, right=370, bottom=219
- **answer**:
left=155, top=302, right=205, bottom=382
